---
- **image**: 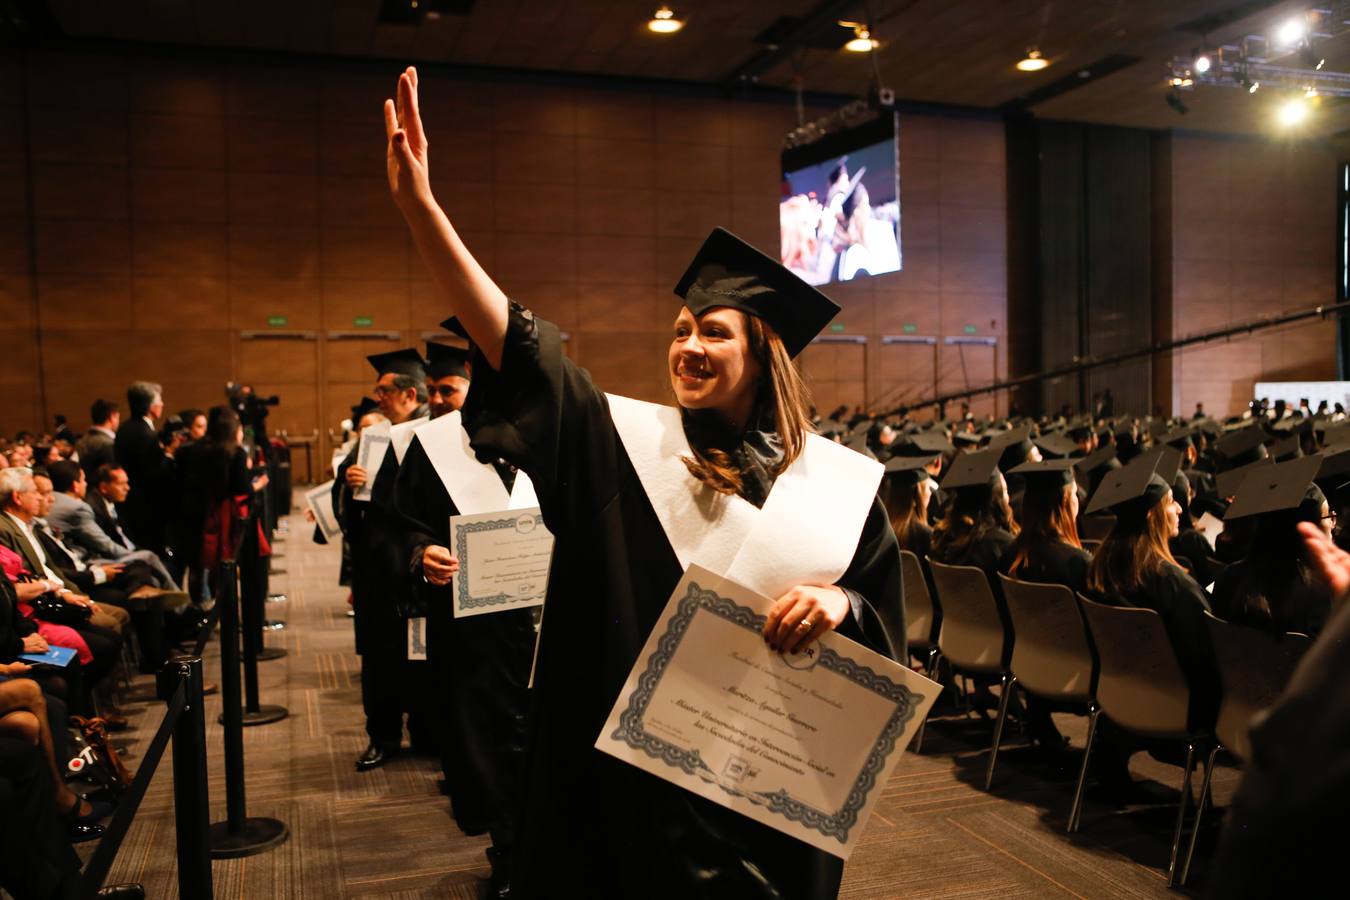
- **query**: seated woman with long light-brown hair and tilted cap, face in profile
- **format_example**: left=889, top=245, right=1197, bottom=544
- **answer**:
left=1087, top=448, right=1219, bottom=730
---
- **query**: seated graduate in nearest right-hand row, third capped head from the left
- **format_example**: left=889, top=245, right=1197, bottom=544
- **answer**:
left=999, top=459, right=1092, bottom=594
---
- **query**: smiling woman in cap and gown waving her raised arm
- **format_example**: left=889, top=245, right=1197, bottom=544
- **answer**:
left=386, top=70, right=905, bottom=899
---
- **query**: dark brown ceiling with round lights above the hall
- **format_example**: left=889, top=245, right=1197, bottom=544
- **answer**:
left=42, top=0, right=1350, bottom=134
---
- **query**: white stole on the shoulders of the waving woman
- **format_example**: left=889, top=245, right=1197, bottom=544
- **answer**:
left=606, top=394, right=884, bottom=598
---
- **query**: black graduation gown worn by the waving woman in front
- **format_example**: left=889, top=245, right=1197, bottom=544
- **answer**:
left=463, top=305, right=903, bottom=900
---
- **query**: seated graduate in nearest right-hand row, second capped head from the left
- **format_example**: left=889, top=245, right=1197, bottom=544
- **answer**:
left=929, top=449, right=1017, bottom=580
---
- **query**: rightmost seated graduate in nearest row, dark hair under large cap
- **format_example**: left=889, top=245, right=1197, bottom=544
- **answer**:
left=1214, top=456, right=1331, bottom=636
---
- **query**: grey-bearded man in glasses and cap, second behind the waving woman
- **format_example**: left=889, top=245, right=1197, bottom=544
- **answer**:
left=333, top=348, right=431, bottom=772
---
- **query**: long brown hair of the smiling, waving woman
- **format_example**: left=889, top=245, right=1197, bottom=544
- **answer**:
left=683, top=313, right=814, bottom=494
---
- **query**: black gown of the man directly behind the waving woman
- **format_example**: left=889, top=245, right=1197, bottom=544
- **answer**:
left=393, top=436, right=535, bottom=850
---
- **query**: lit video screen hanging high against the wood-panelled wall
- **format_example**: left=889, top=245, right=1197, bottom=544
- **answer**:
left=779, top=116, right=902, bottom=285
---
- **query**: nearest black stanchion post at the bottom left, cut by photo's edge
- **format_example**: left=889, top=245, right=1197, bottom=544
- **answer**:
left=173, top=656, right=215, bottom=900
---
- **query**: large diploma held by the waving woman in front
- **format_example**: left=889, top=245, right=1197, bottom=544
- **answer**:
left=595, top=565, right=941, bottom=860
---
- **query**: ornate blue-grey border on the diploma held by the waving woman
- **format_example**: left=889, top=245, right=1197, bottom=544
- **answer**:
left=610, top=582, right=922, bottom=845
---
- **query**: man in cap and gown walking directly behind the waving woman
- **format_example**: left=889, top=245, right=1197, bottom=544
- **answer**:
left=393, top=334, right=535, bottom=874
